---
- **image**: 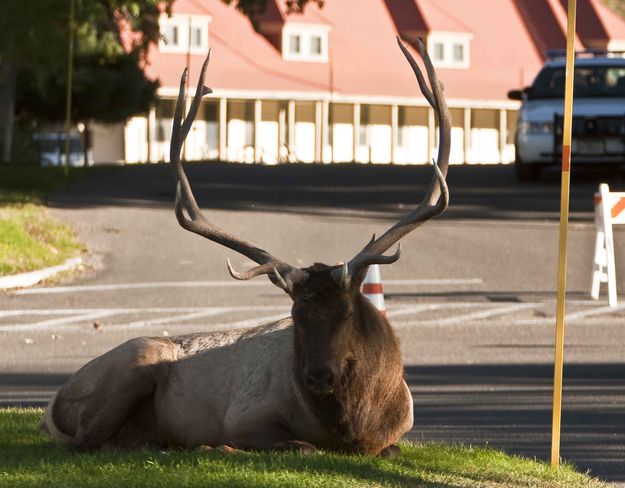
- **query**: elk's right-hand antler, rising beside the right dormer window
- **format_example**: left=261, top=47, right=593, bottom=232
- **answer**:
left=333, top=37, right=451, bottom=287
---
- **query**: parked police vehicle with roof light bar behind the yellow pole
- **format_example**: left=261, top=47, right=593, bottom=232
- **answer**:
left=508, top=51, right=625, bottom=181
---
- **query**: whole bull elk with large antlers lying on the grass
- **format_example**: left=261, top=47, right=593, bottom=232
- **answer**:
left=42, top=38, right=451, bottom=455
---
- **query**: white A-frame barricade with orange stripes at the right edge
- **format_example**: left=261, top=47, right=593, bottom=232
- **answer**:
left=590, top=183, right=625, bottom=307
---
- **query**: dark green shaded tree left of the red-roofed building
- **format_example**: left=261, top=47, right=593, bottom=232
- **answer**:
left=0, top=0, right=173, bottom=161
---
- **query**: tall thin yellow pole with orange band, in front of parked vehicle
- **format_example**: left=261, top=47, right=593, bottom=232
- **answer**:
left=551, top=0, right=577, bottom=466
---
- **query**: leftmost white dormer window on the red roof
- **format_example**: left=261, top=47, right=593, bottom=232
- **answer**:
left=158, top=15, right=211, bottom=54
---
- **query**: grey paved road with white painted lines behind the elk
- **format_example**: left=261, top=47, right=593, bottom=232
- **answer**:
left=0, top=164, right=625, bottom=482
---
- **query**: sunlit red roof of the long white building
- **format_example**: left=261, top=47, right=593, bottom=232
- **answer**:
left=147, top=0, right=625, bottom=100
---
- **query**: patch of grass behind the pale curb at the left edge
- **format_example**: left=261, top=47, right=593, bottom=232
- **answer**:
left=0, top=164, right=92, bottom=276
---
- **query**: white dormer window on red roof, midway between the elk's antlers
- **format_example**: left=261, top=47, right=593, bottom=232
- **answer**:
left=282, top=23, right=330, bottom=63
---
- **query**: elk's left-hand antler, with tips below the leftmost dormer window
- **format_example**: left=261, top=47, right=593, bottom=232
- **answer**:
left=169, top=51, right=308, bottom=293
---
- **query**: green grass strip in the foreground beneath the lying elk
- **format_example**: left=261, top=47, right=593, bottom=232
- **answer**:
left=0, top=409, right=605, bottom=488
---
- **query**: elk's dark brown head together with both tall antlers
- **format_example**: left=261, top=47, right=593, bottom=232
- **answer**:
left=170, top=38, right=451, bottom=395
